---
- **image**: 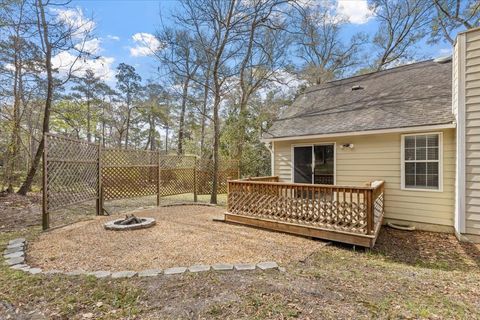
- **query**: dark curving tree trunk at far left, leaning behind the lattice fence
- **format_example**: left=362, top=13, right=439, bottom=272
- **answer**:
left=18, top=0, right=53, bottom=195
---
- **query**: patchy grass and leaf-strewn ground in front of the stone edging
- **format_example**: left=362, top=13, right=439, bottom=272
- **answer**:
left=0, top=194, right=480, bottom=319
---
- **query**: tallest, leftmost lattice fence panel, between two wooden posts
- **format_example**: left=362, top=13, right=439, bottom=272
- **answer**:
left=43, top=134, right=100, bottom=229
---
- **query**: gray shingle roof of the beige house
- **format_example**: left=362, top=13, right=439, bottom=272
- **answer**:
left=263, top=60, right=455, bottom=139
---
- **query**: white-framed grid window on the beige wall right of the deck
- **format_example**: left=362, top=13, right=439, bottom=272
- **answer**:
left=402, top=133, right=442, bottom=190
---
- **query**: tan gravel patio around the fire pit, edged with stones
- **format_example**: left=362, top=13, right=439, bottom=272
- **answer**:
left=27, top=205, right=325, bottom=271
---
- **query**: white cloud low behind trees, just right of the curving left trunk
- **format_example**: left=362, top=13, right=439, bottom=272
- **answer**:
left=52, top=51, right=115, bottom=81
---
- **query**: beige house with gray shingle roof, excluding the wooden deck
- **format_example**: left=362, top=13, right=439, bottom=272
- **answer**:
left=251, top=28, right=480, bottom=245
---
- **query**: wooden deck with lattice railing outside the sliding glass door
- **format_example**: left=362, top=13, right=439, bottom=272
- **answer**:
left=225, top=176, right=384, bottom=248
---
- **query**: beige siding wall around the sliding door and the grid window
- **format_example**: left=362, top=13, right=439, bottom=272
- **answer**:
left=274, top=129, right=456, bottom=226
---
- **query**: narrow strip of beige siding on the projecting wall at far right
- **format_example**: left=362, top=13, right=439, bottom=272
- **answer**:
left=464, top=29, right=480, bottom=235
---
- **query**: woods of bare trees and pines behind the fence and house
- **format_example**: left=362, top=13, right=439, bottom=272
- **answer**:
left=0, top=0, right=480, bottom=202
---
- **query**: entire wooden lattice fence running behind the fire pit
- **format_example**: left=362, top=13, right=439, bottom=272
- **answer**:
left=43, top=134, right=239, bottom=229
